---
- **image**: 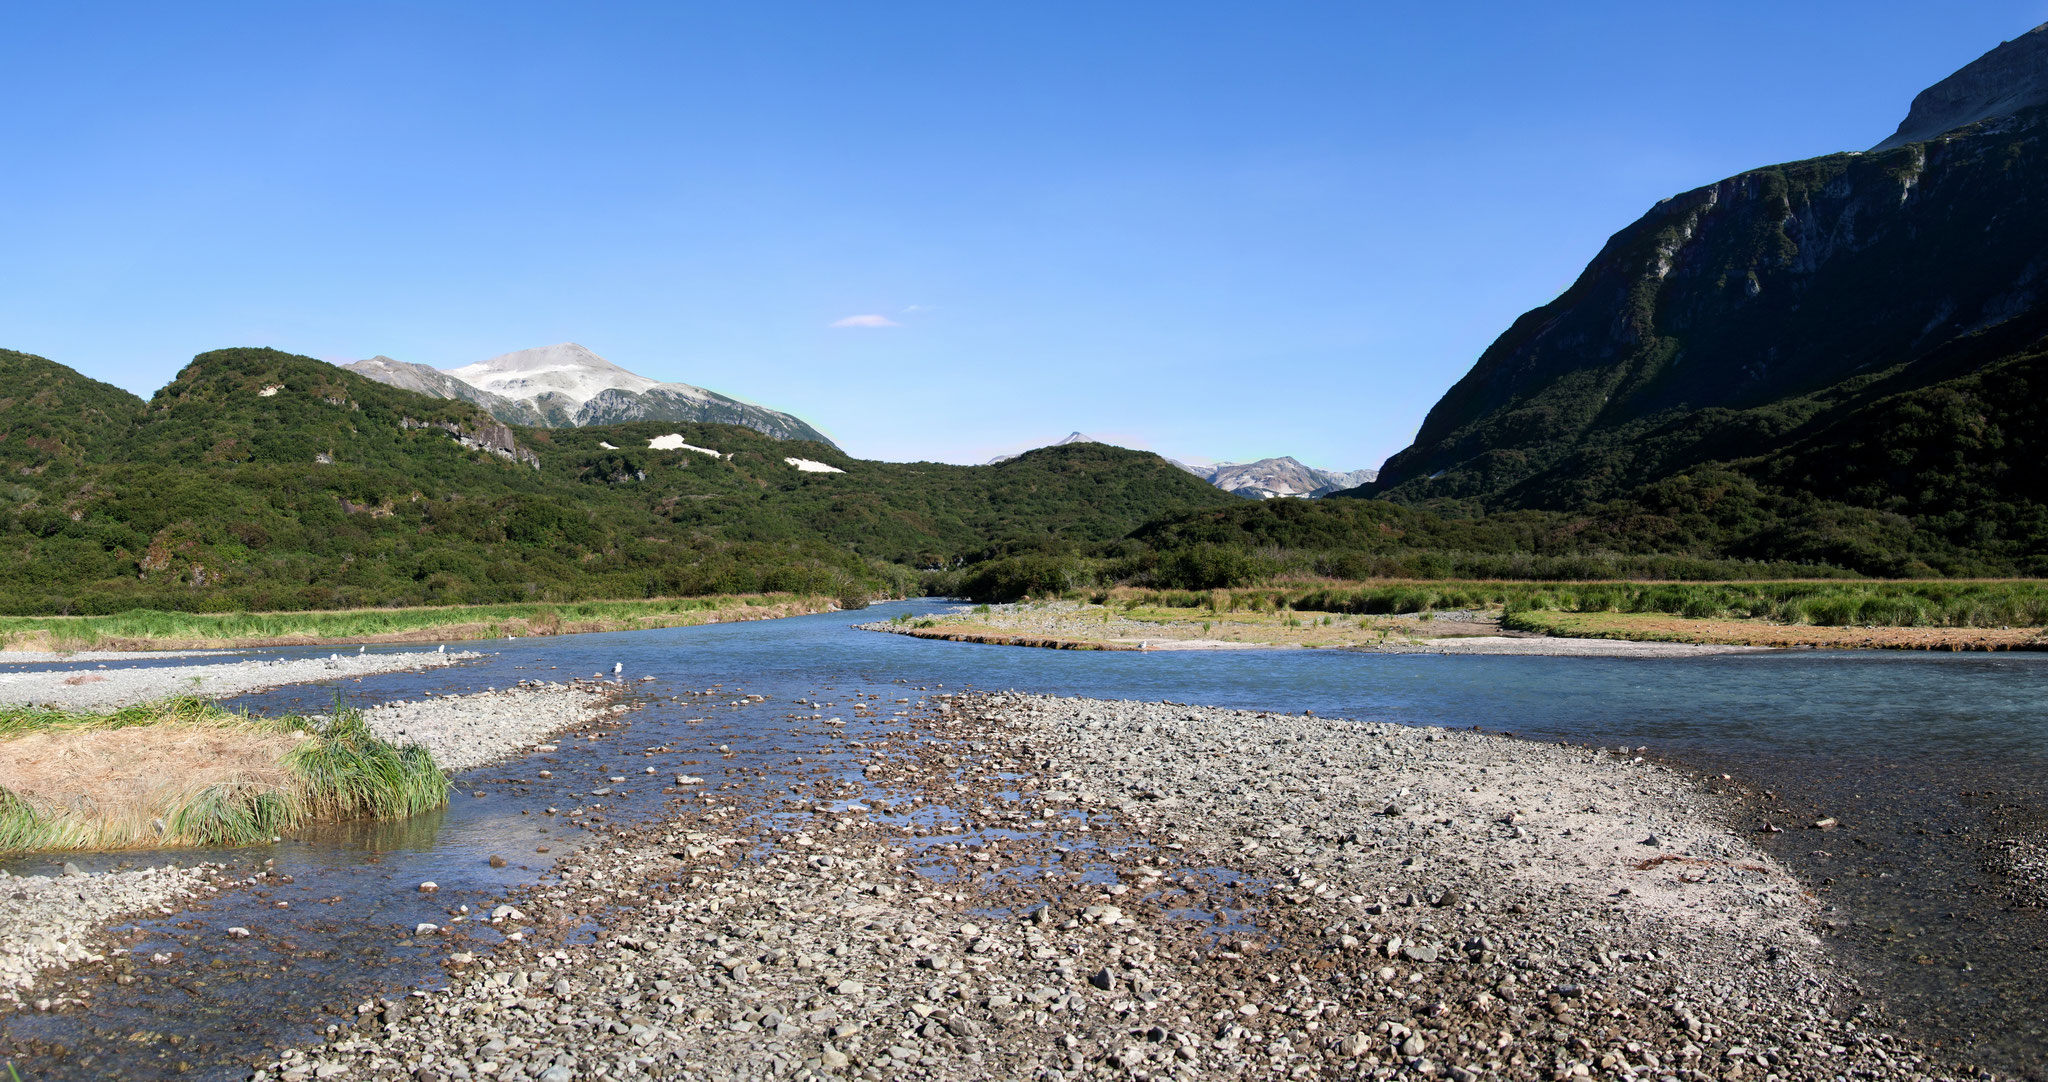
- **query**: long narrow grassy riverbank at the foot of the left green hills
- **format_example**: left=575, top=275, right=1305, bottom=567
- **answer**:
left=0, top=594, right=840, bottom=652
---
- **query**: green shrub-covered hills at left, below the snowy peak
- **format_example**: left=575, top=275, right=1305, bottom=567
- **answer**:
left=0, top=348, right=1237, bottom=613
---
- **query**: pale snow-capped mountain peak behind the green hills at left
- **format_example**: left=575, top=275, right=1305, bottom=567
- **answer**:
left=342, top=342, right=831, bottom=445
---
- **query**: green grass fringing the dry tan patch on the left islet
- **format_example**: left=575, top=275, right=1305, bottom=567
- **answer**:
left=0, top=699, right=449, bottom=852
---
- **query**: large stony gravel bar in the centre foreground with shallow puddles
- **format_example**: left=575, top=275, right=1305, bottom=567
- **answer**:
left=254, top=695, right=1976, bottom=1082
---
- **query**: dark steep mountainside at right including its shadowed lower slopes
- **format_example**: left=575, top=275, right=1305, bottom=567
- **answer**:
left=1360, top=35, right=2048, bottom=555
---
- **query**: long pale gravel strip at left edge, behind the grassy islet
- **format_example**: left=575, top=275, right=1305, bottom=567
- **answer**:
left=0, top=650, right=483, bottom=711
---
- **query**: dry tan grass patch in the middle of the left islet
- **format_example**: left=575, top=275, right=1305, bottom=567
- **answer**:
left=0, top=725, right=305, bottom=844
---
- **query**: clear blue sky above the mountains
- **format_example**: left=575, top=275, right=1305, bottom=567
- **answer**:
left=0, top=0, right=2048, bottom=469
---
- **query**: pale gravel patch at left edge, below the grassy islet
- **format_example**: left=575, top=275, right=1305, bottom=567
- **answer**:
left=0, top=865, right=219, bottom=1010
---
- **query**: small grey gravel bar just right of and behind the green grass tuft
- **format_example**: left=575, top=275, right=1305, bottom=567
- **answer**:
left=362, top=680, right=631, bottom=775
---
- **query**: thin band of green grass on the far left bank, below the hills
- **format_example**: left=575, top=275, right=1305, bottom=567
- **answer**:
left=0, top=594, right=825, bottom=650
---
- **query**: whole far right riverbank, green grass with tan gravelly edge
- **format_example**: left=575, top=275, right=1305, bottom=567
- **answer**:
left=864, top=580, right=2048, bottom=654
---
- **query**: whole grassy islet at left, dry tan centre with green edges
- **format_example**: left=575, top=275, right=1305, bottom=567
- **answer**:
left=0, top=699, right=449, bottom=852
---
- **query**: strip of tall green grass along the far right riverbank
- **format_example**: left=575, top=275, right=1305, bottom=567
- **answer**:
left=1139, top=580, right=2048, bottom=627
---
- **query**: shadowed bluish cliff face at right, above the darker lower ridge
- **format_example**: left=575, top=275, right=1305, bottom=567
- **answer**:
left=1370, top=97, right=2048, bottom=506
